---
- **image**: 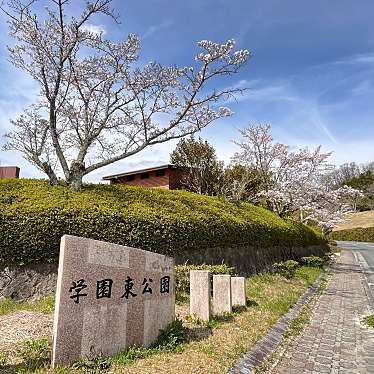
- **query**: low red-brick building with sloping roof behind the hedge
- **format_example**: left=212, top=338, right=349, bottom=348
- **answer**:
left=103, top=164, right=185, bottom=190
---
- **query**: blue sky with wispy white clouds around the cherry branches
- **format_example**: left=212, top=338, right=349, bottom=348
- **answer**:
left=0, top=0, right=374, bottom=181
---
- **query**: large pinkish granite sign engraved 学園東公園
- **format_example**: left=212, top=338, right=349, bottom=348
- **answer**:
left=52, top=235, right=175, bottom=367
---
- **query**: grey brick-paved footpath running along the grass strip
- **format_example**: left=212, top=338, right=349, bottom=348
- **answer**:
left=272, top=250, right=374, bottom=374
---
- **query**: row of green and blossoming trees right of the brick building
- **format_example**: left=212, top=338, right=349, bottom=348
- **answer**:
left=170, top=124, right=368, bottom=234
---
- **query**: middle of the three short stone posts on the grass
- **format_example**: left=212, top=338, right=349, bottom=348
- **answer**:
left=213, top=274, right=232, bottom=315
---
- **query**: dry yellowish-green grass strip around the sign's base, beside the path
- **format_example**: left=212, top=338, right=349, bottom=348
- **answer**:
left=0, top=267, right=321, bottom=374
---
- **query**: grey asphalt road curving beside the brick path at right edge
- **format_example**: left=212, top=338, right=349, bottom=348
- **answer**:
left=337, top=241, right=374, bottom=309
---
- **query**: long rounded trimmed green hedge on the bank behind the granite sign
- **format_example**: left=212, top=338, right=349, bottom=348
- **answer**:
left=0, top=179, right=322, bottom=265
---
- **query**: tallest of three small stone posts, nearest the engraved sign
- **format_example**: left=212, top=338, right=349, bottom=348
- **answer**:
left=190, top=270, right=210, bottom=321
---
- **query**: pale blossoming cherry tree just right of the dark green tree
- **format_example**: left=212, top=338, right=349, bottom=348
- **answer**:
left=233, top=124, right=331, bottom=216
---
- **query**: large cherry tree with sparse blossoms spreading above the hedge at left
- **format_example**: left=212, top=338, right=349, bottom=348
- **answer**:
left=1, top=0, right=249, bottom=189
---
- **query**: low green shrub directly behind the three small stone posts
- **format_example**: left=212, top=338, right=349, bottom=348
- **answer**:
left=175, top=264, right=235, bottom=295
